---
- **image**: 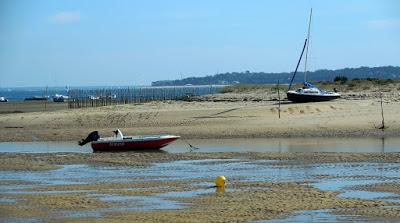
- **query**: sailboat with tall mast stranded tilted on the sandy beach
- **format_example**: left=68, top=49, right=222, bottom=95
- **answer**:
left=286, top=8, right=340, bottom=102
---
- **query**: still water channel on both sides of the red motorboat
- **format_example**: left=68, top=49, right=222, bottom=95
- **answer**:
left=0, top=137, right=400, bottom=153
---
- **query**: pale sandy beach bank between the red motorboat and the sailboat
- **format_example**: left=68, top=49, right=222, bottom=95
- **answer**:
left=0, top=87, right=400, bottom=141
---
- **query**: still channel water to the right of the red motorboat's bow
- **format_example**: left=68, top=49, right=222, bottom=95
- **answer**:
left=172, top=137, right=400, bottom=153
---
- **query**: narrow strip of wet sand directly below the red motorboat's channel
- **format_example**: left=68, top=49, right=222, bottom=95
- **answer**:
left=0, top=151, right=400, bottom=171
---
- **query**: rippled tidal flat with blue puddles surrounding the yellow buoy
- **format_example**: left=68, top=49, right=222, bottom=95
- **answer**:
left=0, top=152, right=400, bottom=222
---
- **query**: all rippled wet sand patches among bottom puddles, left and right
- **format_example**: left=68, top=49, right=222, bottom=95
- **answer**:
left=0, top=179, right=400, bottom=222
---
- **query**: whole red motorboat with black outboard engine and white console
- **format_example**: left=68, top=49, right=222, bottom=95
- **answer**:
left=79, top=129, right=180, bottom=152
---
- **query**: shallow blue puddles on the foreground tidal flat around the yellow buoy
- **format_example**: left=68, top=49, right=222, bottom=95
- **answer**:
left=0, top=159, right=400, bottom=222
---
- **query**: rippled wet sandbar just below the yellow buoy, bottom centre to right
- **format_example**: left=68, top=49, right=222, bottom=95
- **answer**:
left=96, top=183, right=390, bottom=222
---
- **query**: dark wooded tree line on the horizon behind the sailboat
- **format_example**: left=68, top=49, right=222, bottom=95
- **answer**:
left=151, top=66, right=400, bottom=86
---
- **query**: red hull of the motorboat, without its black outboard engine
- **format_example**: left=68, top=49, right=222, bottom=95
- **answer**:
left=91, top=136, right=179, bottom=152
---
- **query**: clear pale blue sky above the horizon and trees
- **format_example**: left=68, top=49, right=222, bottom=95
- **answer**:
left=0, top=0, right=400, bottom=87
